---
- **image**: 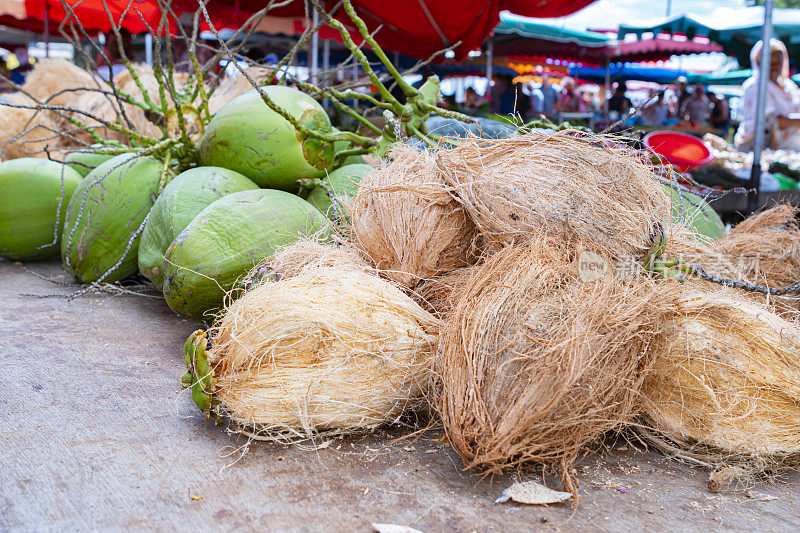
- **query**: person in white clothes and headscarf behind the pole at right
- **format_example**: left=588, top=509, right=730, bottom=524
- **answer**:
left=734, top=39, right=800, bottom=150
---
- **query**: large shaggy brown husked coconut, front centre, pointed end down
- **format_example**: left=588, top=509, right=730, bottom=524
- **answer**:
left=436, top=235, right=677, bottom=493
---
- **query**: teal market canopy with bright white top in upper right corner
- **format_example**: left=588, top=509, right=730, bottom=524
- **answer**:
left=618, top=6, right=800, bottom=65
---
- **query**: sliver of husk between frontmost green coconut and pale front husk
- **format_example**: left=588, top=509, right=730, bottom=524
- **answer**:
left=242, top=239, right=375, bottom=290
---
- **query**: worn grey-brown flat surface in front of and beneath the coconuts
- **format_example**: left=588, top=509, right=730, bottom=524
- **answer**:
left=0, top=260, right=800, bottom=532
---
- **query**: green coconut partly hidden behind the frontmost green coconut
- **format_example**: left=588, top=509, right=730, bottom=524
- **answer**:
left=139, top=167, right=258, bottom=289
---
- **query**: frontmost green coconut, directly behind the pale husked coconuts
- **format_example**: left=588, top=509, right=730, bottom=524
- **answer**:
left=163, top=189, right=330, bottom=321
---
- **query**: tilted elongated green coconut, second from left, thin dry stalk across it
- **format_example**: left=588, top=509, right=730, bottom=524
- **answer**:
left=61, top=154, right=163, bottom=283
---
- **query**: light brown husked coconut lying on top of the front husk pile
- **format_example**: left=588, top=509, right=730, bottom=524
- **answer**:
left=437, top=132, right=671, bottom=258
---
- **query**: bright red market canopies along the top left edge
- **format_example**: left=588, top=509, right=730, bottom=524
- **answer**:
left=0, top=0, right=595, bottom=58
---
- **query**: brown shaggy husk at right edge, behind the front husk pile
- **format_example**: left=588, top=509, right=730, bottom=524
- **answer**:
left=714, top=204, right=800, bottom=310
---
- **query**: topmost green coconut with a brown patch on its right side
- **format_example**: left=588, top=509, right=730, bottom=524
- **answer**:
left=198, top=85, right=334, bottom=192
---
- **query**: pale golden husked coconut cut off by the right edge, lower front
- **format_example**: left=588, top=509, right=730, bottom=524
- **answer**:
left=642, top=290, right=800, bottom=471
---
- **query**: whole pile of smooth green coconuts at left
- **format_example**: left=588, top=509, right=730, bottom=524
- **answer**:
left=0, top=85, right=372, bottom=322
